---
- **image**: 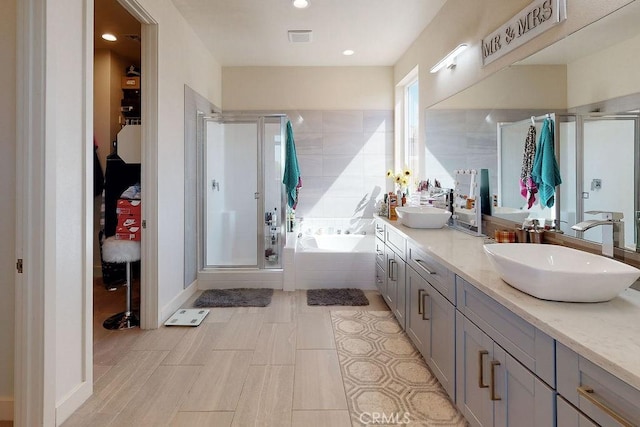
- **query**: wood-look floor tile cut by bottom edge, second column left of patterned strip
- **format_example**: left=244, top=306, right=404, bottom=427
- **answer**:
left=232, top=366, right=294, bottom=427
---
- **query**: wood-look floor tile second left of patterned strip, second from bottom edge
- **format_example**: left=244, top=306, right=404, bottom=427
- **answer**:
left=251, top=323, right=296, bottom=365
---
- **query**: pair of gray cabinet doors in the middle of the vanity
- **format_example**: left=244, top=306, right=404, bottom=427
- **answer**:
left=406, top=266, right=456, bottom=400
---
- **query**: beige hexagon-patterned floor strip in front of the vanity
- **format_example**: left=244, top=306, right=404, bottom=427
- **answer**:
left=331, top=311, right=467, bottom=427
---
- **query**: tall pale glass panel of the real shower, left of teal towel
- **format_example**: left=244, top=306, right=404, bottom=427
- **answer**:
left=205, top=120, right=259, bottom=267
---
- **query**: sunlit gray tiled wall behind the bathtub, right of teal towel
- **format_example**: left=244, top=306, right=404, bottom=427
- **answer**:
left=287, top=110, right=393, bottom=218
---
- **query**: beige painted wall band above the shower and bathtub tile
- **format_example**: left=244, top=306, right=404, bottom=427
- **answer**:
left=222, top=67, right=393, bottom=111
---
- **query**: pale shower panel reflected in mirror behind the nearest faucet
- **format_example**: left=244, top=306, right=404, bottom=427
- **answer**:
left=582, top=116, right=638, bottom=250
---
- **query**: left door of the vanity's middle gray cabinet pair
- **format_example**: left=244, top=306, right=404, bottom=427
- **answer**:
left=405, top=267, right=429, bottom=359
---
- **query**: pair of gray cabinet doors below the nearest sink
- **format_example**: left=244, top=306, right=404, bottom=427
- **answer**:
left=456, top=312, right=556, bottom=427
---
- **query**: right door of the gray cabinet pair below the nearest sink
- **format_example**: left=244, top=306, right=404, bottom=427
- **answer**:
left=488, top=343, right=555, bottom=427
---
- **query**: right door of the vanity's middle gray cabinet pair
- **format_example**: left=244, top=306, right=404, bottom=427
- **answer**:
left=422, top=284, right=456, bottom=401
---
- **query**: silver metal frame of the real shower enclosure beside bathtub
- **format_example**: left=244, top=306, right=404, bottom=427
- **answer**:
left=197, top=113, right=288, bottom=271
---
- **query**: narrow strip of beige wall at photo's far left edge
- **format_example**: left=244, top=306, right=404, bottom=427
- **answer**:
left=0, top=0, right=16, bottom=420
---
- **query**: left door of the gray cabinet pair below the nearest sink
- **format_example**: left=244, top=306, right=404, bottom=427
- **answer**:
left=456, top=311, right=494, bottom=427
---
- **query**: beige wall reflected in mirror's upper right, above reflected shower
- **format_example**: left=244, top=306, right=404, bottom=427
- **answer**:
left=567, top=31, right=640, bottom=108
